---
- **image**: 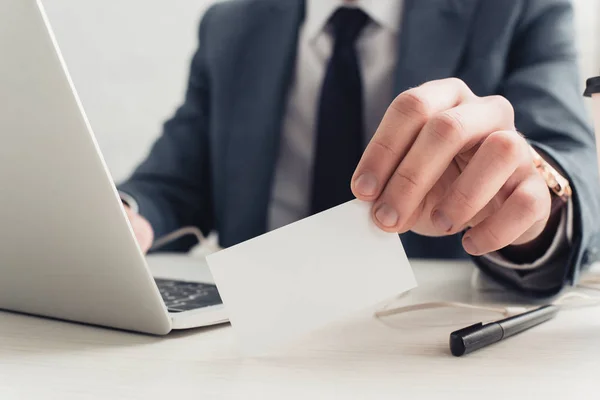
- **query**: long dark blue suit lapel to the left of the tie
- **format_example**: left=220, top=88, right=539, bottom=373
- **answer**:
left=224, top=0, right=305, bottom=244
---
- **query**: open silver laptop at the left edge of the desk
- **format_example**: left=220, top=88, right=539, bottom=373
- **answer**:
left=0, top=0, right=227, bottom=335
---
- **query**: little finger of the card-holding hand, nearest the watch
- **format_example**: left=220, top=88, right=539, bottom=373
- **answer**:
left=463, top=174, right=550, bottom=256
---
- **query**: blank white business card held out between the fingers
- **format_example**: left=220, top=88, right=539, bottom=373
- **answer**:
left=207, top=200, right=416, bottom=354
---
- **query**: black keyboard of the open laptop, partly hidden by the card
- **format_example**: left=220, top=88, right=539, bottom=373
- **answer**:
left=154, top=279, right=222, bottom=312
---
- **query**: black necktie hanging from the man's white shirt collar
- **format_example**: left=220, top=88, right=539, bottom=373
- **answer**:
left=310, top=8, right=369, bottom=214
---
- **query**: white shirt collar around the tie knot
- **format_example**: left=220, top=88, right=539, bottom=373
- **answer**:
left=304, top=0, right=404, bottom=39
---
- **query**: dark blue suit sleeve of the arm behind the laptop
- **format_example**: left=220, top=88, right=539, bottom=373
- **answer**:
left=118, top=10, right=214, bottom=251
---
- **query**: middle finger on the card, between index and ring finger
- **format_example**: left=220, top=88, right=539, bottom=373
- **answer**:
left=374, top=97, right=518, bottom=232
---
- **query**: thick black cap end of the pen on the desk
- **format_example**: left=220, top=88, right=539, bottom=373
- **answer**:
left=450, top=322, right=504, bottom=357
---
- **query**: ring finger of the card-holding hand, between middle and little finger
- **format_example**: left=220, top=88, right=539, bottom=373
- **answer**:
left=431, top=131, right=534, bottom=234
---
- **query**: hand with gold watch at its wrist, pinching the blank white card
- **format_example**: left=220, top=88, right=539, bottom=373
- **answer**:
left=352, top=78, right=551, bottom=255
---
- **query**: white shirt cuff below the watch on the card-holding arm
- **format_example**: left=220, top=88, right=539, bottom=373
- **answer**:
left=483, top=199, right=573, bottom=270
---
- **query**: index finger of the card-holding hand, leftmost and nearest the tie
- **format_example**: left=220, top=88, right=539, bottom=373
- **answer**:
left=352, top=79, right=475, bottom=201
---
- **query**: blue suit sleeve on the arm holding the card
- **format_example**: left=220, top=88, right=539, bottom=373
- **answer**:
left=476, top=0, right=600, bottom=296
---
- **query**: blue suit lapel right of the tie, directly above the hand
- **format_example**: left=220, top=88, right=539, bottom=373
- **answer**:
left=395, top=0, right=479, bottom=93
